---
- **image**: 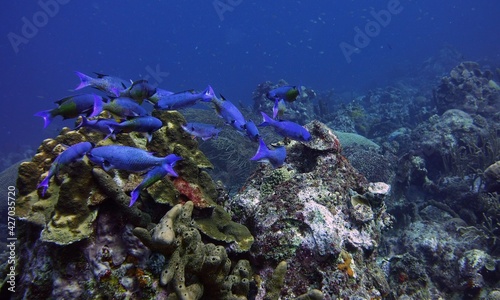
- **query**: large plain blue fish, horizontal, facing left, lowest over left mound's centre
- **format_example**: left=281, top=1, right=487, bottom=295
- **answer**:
left=87, top=145, right=176, bottom=172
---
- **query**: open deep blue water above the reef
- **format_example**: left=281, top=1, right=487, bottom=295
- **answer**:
left=0, top=0, right=500, bottom=164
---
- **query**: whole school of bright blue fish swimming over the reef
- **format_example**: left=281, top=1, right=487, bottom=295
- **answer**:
left=35, top=72, right=311, bottom=206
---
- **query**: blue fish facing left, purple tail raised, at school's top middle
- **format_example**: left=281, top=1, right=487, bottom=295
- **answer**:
left=155, top=86, right=215, bottom=110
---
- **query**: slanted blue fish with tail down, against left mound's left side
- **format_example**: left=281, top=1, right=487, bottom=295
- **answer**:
left=36, top=142, right=94, bottom=197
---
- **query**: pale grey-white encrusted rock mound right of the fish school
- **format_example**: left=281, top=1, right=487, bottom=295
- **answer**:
left=226, top=121, right=392, bottom=299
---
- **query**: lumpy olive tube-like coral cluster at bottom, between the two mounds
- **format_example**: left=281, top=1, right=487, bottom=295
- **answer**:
left=134, top=201, right=252, bottom=299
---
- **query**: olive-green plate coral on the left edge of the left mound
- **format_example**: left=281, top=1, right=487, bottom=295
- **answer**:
left=17, top=129, right=97, bottom=245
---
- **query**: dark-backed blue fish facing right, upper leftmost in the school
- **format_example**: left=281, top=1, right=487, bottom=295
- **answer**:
left=35, top=94, right=103, bottom=128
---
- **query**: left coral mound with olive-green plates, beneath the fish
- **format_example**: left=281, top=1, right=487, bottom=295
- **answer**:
left=9, top=112, right=253, bottom=299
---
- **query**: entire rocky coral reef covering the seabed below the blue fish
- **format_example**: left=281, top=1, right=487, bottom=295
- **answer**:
left=7, top=59, right=500, bottom=300
